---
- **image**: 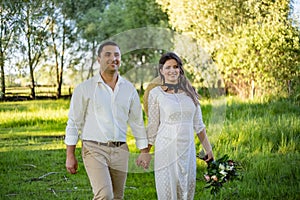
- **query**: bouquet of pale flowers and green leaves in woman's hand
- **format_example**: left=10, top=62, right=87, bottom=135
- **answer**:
left=202, top=154, right=240, bottom=195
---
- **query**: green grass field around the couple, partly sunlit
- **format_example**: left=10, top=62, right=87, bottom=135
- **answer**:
left=0, top=97, right=300, bottom=200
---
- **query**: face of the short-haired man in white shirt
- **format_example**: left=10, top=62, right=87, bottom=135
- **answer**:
left=97, top=45, right=121, bottom=73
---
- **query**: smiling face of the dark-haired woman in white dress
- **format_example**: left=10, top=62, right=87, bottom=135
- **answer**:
left=160, top=59, right=180, bottom=84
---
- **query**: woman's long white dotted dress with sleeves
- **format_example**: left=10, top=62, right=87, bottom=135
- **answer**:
left=147, top=86, right=205, bottom=200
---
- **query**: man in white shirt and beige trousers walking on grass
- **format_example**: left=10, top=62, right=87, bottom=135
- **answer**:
left=65, top=41, right=151, bottom=199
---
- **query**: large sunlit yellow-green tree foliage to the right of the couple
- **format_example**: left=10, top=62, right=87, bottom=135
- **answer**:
left=157, top=0, right=300, bottom=98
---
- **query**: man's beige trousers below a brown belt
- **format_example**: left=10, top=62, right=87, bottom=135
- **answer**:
left=82, top=141, right=129, bottom=200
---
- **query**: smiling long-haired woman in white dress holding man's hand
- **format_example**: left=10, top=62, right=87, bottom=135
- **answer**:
left=146, top=52, right=213, bottom=200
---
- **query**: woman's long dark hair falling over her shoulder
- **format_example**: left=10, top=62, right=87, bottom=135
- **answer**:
left=158, top=52, right=199, bottom=106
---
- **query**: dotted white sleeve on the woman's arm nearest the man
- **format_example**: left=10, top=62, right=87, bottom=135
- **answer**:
left=147, top=91, right=160, bottom=145
